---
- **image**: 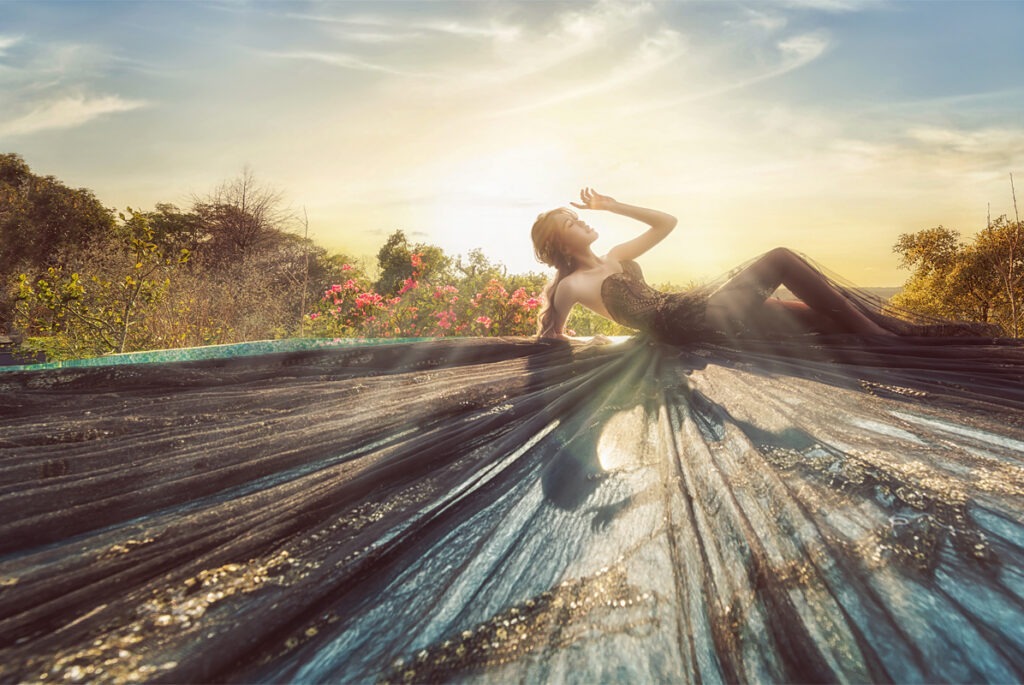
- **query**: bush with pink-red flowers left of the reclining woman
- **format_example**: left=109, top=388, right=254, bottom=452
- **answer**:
left=306, top=254, right=541, bottom=338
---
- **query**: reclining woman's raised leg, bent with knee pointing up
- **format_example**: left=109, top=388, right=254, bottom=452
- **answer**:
left=707, top=248, right=892, bottom=335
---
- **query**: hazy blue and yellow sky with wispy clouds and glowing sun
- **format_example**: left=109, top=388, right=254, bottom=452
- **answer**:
left=0, top=0, right=1024, bottom=286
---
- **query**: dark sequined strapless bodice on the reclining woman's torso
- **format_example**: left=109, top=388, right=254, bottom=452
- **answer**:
left=601, top=261, right=713, bottom=342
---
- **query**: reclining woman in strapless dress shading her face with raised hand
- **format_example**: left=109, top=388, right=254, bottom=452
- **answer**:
left=532, top=187, right=950, bottom=343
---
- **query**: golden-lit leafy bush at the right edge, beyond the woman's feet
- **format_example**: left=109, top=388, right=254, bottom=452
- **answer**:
left=892, top=216, right=1024, bottom=336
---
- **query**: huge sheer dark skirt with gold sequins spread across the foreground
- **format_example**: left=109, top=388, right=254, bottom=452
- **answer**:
left=0, top=337, right=1024, bottom=683
